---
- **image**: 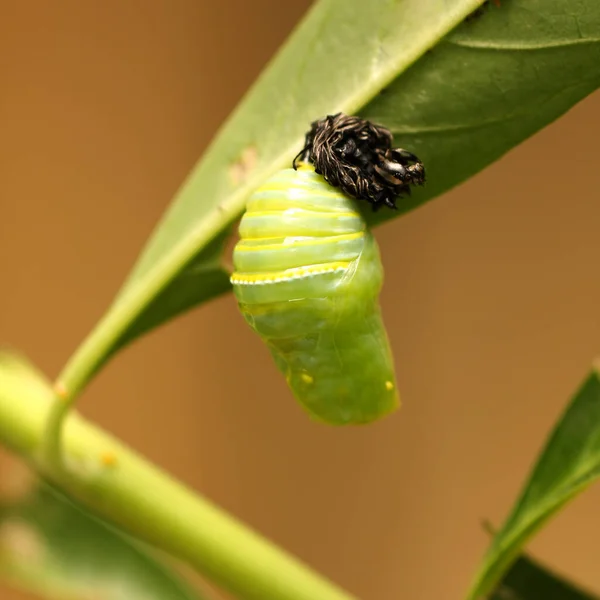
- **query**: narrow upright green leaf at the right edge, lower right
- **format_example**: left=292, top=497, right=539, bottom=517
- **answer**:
left=467, top=371, right=600, bottom=600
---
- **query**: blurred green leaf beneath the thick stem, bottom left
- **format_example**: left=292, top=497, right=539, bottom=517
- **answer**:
left=0, top=482, right=205, bottom=600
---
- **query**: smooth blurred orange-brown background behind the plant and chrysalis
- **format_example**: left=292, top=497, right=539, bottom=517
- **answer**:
left=0, top=0, right=600, bottom=600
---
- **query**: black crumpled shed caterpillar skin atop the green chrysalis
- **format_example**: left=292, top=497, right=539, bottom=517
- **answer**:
left=293, top=113, right=425, bottom=210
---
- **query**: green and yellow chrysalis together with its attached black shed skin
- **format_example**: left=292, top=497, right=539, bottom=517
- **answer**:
left=231, top=115, right=424, bottom=425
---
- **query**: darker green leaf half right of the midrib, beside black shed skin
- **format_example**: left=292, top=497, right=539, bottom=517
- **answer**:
left=361, top=0, right=600, bottom=222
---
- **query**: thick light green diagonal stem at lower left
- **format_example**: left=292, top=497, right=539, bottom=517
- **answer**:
left=0, top=356, right=353, bottom=600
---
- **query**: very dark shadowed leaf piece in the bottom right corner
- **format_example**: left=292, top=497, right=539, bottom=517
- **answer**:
left=489, top=556, right=598, bottom=600
